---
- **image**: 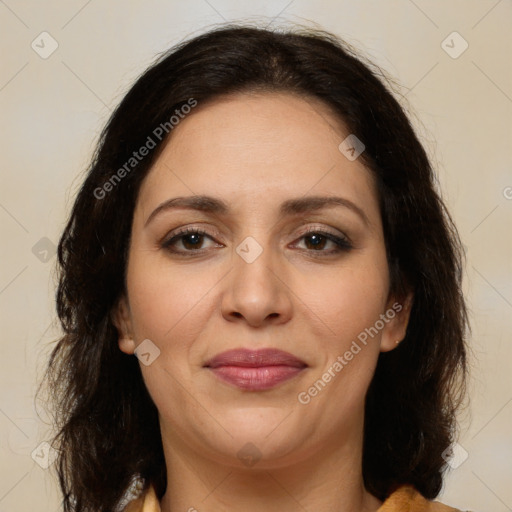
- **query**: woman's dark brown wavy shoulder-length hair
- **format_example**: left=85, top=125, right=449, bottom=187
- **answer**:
left=46, top=25, right=467, bottom=512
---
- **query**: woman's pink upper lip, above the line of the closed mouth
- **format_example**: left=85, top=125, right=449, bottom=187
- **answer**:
left=204, top=348, right=307, bottom=368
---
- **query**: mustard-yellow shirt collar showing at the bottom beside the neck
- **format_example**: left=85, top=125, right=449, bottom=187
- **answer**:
left=123, top=485, right=460, bottom=512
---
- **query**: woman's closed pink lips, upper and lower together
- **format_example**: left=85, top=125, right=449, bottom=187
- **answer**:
left=204, top=349, right=307, bottom=391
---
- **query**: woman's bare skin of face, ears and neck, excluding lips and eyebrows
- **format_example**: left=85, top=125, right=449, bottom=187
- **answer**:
left=114, top=92, right=411, bottom=512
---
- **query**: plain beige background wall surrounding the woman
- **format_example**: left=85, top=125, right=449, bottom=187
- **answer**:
left=0, top=0, right=512, bottom=512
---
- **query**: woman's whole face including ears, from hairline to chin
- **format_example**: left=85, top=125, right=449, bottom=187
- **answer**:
left=115, top=93, right=408, bottom=468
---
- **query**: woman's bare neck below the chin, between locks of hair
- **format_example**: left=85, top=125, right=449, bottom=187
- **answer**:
left=161, top=418, right=382, bottom=512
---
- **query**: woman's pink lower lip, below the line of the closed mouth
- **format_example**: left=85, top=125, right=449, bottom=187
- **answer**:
left=210, top=366, right=304, bottom=391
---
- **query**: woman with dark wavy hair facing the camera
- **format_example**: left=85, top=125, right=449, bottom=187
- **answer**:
left=44, top=26, right=467, bottom=512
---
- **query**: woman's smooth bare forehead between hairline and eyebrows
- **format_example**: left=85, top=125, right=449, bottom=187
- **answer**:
left=134, top=92, right=378, bottom=222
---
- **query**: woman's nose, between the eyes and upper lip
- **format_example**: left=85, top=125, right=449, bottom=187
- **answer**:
left=222, top=240, right=293, bottom=327
